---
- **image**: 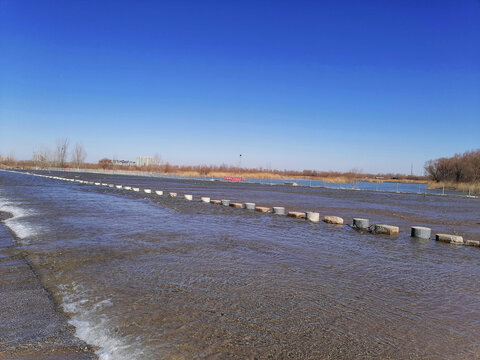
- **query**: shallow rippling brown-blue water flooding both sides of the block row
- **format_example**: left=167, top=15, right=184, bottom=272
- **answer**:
left=0, top=172, right=480, bottom=359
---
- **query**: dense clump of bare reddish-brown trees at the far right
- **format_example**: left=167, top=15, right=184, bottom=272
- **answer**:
left=425, top=149, right=480, bottom=183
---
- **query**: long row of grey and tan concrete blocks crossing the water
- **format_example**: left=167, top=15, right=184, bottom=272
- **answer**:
left=16, top=174, right=480, bottom=247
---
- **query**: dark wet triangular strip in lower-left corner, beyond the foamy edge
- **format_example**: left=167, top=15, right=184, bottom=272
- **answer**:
left=0, top=212, right=97, bottom=360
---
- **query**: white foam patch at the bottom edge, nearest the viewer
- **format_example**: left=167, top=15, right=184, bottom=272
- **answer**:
left=60, top=285, right=143, bottom=360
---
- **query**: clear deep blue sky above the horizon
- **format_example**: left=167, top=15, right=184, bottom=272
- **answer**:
left=0, top=0, right=480, bottom=174
